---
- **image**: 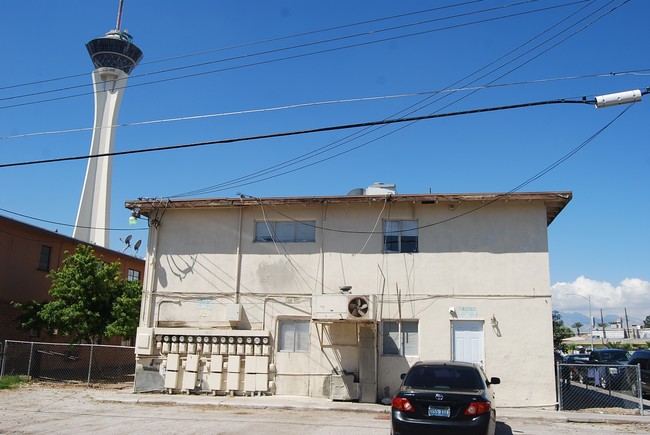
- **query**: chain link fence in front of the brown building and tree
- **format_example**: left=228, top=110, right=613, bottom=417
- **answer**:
left=0, top=340, right=135, bottom=384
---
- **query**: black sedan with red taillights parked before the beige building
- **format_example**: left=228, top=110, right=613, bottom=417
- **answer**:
left=391, top=361, right=501, bottom=435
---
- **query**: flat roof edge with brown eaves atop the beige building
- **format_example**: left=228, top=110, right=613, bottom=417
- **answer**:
left=125, top=192, right=573, bottom=225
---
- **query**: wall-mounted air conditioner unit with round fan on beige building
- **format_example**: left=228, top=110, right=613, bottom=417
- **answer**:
left=311, top=294, right=375, bottom=322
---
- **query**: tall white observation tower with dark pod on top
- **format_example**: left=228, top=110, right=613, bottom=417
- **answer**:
left=73, top=29, right=142, bottom=248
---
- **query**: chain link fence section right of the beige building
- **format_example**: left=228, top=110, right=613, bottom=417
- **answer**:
left=557, top=364, right=644, bottom=415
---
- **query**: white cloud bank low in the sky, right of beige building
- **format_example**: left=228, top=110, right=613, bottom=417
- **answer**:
left=551, top=276, right=650, bottom=324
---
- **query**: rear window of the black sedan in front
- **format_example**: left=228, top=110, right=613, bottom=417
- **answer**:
left=404, top=366, right=485, bottom=390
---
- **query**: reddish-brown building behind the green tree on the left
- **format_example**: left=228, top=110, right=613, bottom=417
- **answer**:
left=0, top=216, right=144, bottom=343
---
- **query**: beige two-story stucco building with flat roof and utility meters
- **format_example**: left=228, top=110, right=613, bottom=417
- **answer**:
left=126, top=185, right=572, bottom=406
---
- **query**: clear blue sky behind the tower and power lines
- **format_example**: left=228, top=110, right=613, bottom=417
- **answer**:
left=0, top=0, right=650, bottom=322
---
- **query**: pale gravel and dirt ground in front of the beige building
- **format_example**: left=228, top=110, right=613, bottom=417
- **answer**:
left=0, top=383, right=650, bottom=435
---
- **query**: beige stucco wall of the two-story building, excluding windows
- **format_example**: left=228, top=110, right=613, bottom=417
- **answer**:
left=139, top=201, right=555, bottom=406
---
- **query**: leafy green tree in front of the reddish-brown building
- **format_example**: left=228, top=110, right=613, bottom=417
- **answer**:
left=38, top=245, right=141, bottom=343
